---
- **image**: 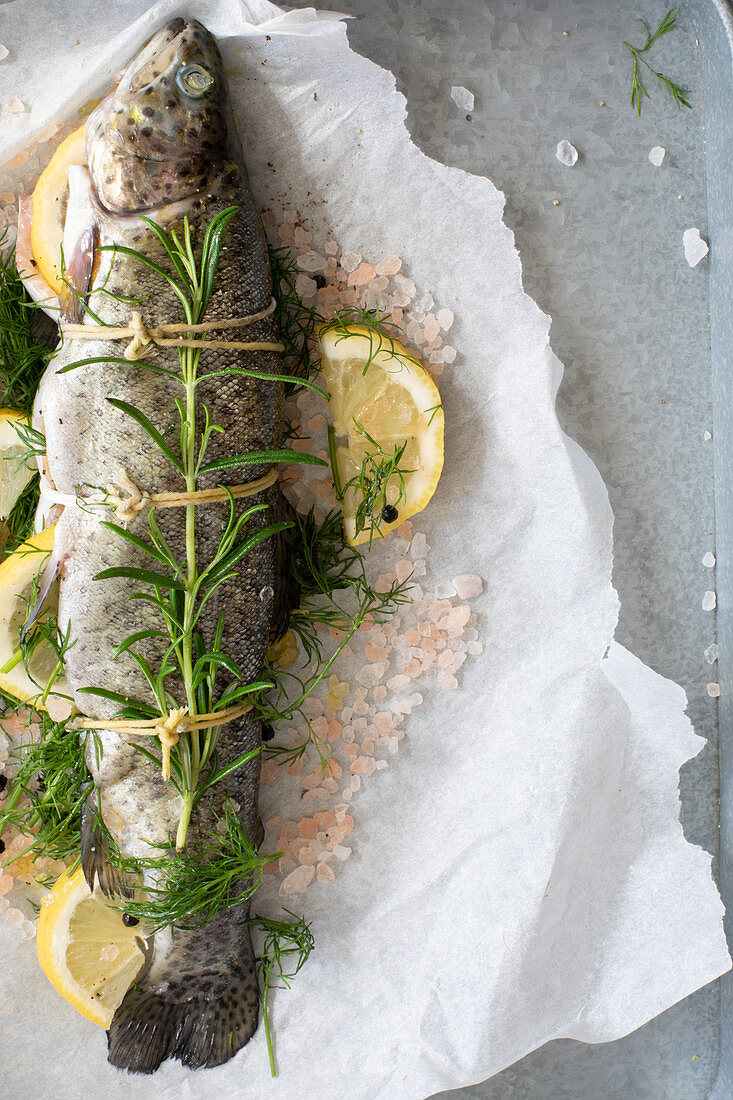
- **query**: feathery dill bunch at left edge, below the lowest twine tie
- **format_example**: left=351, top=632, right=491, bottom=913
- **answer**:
left=0, top=711, right=96, bottom=860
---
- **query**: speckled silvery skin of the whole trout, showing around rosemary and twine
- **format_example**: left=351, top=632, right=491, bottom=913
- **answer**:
left=36, top=20, right=283, bottom=1073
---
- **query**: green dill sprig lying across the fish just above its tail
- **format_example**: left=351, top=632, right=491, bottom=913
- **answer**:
left=108, top=802, right=283, bottom=935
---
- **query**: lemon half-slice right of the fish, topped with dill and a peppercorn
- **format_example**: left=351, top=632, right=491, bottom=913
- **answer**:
left=319, top=322, right=445, bottom=546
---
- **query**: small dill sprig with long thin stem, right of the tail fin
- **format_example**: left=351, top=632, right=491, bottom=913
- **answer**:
left=250, top=909, right=314, bottom=1077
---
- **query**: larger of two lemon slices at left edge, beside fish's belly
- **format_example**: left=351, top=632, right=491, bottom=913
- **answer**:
left=0, top=527, right=72, bottom=721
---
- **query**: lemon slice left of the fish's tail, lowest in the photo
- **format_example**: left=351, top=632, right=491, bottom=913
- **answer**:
left=37, top=868, right=145, bottom=1027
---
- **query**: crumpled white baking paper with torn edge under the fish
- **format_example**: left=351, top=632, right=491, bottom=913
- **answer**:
left=0, top=0, right=730, bottom=1100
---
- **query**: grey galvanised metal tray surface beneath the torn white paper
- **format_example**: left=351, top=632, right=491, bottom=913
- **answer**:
left=283, top=0, right=733, bottom=1100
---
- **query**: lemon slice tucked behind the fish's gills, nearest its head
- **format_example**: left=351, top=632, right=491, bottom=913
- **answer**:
left=31, top=127, right=87, bottom=294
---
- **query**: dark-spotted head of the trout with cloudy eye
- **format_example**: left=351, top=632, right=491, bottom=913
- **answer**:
left=86, top=19, right=239, bottom=213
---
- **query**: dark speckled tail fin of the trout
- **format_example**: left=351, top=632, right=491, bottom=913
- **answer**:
left=107, top=932, right=260, bottom=1074
